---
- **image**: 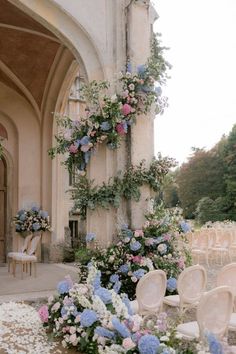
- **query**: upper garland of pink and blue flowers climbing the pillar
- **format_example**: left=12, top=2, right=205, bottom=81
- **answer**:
left=49, top=35, right=170, bottom=172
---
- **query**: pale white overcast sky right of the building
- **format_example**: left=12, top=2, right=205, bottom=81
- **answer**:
left=153, top=0, right=236, bottom=163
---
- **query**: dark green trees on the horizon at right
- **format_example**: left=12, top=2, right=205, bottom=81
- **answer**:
left=162, top=125, right=236, bottom=223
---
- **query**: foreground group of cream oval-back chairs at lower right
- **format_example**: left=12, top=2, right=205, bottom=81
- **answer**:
left=131, top=263, right=236, bottom=340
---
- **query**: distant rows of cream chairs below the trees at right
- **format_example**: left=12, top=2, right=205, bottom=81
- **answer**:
left=186, top=227, right=236, bottom=266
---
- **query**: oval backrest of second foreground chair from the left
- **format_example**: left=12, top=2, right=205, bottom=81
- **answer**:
left=177, top=264, right=207, bottom=304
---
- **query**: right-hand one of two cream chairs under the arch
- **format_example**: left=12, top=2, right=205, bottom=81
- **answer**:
left=12, top=235, right=41, bottom=279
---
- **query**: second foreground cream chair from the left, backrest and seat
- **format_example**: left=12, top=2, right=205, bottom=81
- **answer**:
left=163, top=264, right=207, bottom=313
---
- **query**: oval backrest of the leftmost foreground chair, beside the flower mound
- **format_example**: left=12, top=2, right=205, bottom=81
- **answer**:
left=136, top=270, right=167, bottom=314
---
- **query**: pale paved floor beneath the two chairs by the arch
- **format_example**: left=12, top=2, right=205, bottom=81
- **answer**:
left=0, top=263, right=78, bottom=303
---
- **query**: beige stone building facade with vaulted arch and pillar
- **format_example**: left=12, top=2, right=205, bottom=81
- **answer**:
left=0, top=0, right=156, bottom=262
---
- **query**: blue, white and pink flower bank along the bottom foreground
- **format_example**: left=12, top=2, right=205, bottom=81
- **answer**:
left=38, top=266, right=235, bottom=354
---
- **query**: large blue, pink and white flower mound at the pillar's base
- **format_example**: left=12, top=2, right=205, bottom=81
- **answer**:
left=80, top=205, right=191, bottom=300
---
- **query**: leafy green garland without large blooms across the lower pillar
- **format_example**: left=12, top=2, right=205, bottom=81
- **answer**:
left=72, top=155, right=175, bottom=218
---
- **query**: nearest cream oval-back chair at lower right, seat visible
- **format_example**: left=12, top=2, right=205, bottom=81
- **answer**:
left=177, top=286, right=233, bottom=340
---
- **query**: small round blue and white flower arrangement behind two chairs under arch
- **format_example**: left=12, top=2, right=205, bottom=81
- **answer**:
left=13, top=206, right=51, bottom=236
